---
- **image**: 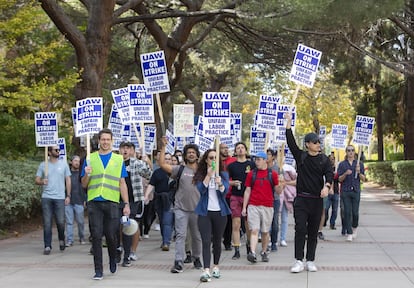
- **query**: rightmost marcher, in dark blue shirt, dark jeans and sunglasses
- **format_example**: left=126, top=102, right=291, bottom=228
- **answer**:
left=338, top=145, right=366, bottom=242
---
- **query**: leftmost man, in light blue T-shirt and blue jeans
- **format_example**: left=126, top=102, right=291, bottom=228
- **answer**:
left=35, top=146, right=71, bottom=255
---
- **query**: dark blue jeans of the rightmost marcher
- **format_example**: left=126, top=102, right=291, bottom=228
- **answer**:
left=341, top=191, right=361, bottom=235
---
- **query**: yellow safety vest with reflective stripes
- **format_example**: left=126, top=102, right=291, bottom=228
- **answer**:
left=88, top=152, right=124, bottom=203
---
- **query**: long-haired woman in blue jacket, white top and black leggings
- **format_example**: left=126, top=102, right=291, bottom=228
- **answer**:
left=193, top=149, right=231, bottom=282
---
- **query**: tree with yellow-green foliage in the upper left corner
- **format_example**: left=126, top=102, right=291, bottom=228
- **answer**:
left=0, top=0, right=78, bottom=118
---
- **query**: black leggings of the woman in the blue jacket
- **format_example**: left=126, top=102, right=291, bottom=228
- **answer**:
left=198, top=211, right=227, bottom=268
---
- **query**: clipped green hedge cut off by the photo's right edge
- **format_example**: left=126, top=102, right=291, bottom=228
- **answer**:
left=392, top=160, right=414, bottom=198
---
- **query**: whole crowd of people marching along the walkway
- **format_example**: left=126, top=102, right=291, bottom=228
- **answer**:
left=35, top=115, right=365, bottom=282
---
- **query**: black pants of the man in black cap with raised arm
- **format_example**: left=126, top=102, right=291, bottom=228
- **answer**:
left=293, top=196, right=323, bottom=261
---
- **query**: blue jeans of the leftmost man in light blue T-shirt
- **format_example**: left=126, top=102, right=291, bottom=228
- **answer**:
left=42, top=198, right=65, bottom=248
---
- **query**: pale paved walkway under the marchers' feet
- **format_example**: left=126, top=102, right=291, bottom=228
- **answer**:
left=0, top=183, right=414, bottom=288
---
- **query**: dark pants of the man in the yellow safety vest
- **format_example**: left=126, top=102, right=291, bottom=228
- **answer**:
left=88, top=201, right=120, bottom=273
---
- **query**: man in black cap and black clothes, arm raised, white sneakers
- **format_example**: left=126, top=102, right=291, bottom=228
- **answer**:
left=285, top=113, right=333, bottom=273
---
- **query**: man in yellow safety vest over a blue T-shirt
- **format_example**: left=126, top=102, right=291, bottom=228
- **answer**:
left=81, top=129, right=130, bottom=280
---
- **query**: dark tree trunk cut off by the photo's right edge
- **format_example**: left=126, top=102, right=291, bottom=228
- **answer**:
left=404, top=76, right=414, bottom=160
